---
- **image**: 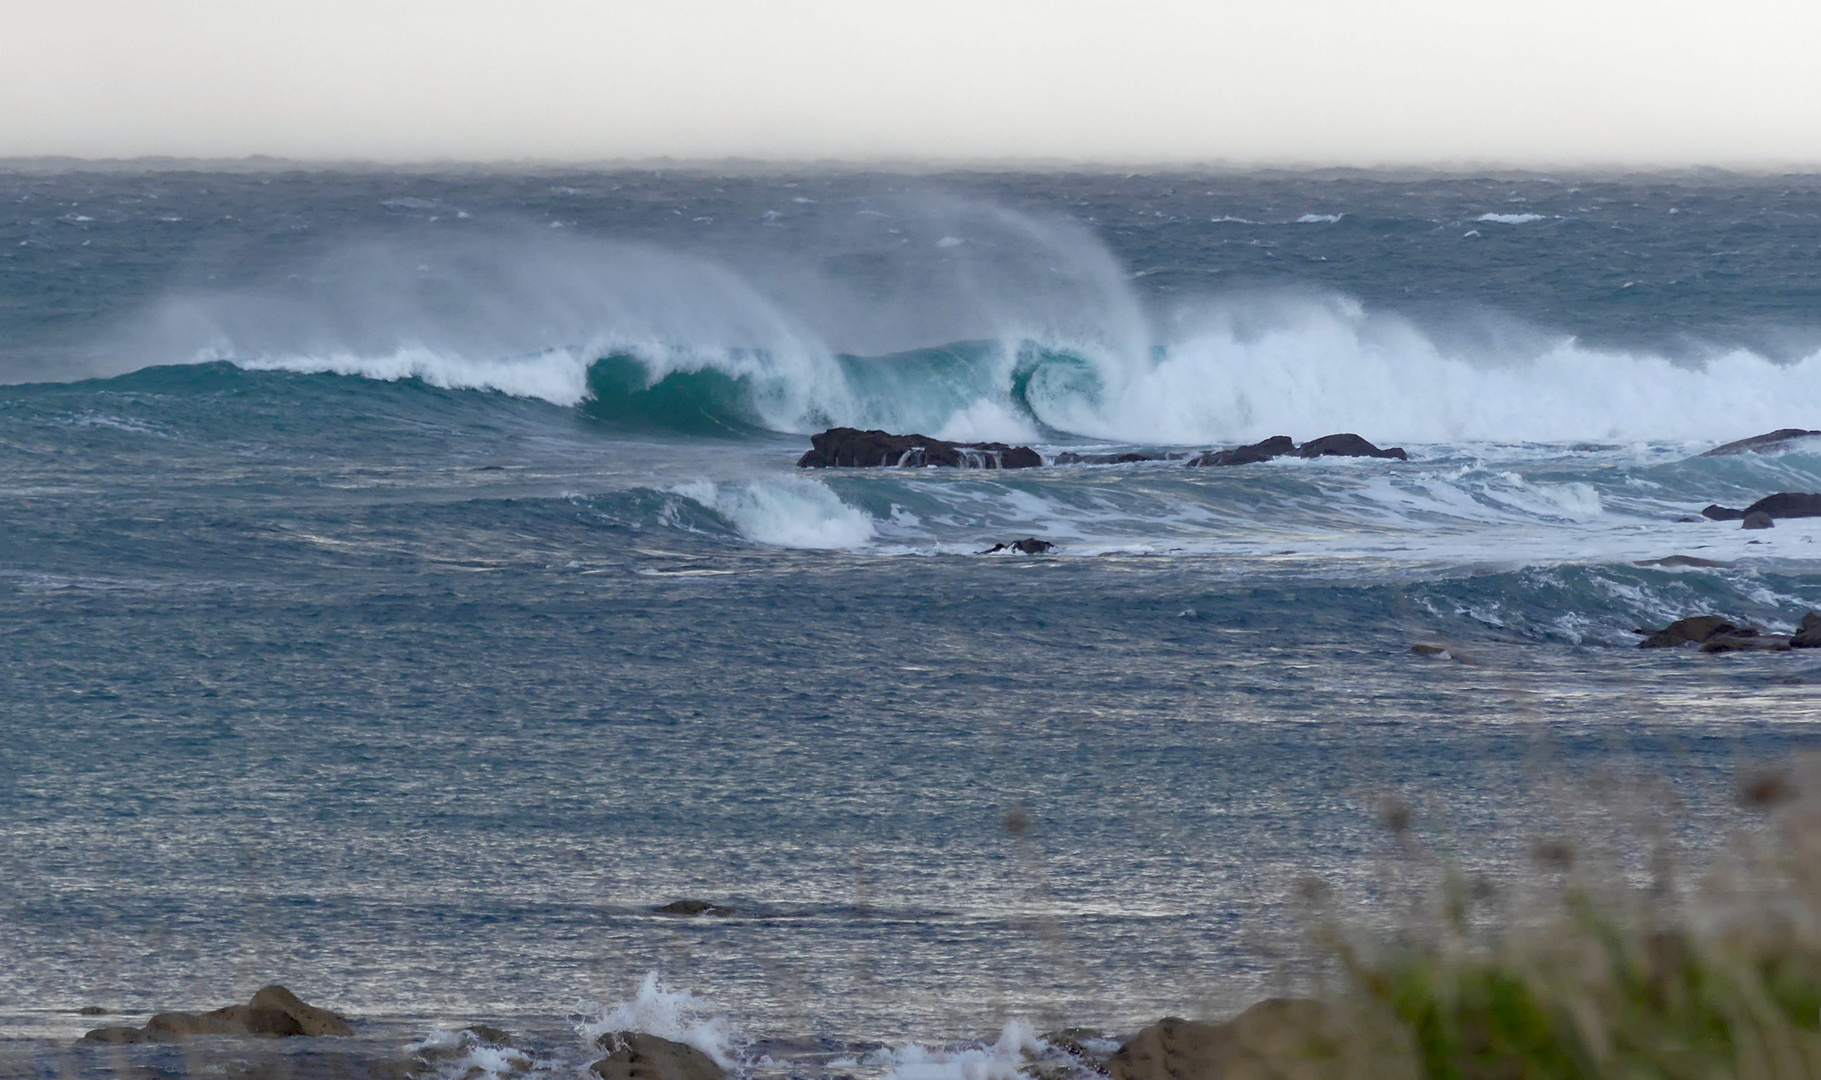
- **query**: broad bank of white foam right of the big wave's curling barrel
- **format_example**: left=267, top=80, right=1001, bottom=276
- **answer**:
left=1031, top=297, right=1821, bottom=444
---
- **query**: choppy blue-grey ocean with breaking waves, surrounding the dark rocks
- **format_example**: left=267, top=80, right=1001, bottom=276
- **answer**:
left=0, top=166, right=1821, bottom=1080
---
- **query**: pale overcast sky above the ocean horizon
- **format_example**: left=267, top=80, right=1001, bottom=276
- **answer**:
left=0, top=0, right=1821, bottom=166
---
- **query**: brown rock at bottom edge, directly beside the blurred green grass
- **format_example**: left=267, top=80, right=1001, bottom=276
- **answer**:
left=1107, top=998, right=1340, bottom=1080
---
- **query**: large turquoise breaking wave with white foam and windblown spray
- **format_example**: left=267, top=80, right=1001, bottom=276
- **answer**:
left=121, top=208, right=1821, bottom=444
